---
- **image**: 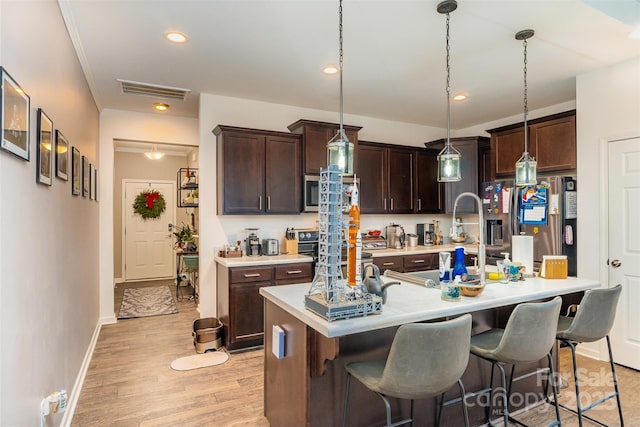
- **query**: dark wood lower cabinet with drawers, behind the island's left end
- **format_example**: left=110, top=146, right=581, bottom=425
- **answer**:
left=217, top=262, right=313, bottom=351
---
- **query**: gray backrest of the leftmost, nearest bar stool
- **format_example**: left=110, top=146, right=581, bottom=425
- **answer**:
left=380, top=314, right=471, bottom=399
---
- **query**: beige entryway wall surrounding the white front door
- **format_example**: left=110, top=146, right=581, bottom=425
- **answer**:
left=113, top=150, right=198, bottom=281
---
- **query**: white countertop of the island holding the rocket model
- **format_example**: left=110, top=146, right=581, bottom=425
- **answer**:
left=260, top=277, right=600, bottom=338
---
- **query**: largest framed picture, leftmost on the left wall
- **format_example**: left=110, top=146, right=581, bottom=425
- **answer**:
left=0, top=67, right=31, bottom=161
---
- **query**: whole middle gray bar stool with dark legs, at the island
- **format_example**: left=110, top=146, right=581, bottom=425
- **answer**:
left=471, top=296, right=562, bottom=426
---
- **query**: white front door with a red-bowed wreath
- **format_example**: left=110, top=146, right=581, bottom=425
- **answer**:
left=122, top=180, right=176, bottom=281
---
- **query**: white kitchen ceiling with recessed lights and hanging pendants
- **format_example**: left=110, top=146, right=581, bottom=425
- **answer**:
left=58, top=0, right=640, bottom=129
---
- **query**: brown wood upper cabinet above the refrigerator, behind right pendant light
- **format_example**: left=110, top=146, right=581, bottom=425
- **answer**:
left=487, top=110, right=576, bottom=178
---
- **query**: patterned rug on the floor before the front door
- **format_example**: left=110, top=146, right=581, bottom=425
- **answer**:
left=118, top=286, right=178, bottom=319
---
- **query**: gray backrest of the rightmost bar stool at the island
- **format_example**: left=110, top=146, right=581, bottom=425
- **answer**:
left=558, top=285, right=622, bottom=342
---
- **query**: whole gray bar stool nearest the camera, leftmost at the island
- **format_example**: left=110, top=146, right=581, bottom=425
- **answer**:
left=342, top=314, right=471, bottom=427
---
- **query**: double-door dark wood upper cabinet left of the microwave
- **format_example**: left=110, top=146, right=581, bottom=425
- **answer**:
left=213, top=125, right=302, bottom=215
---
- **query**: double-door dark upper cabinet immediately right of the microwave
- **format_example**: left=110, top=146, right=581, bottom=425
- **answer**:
left=358, top=141, right=415, bottom=214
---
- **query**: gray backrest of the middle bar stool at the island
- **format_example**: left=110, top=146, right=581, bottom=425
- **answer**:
left=493, top=296, right=562, bottom=364
